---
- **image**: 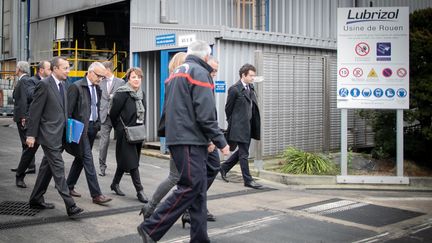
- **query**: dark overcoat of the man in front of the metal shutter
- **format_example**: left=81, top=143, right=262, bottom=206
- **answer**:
left=225, top=80, right=261, bottom=143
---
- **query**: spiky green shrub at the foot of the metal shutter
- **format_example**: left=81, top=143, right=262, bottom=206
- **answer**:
left=281, top=146, right=336, bottom=175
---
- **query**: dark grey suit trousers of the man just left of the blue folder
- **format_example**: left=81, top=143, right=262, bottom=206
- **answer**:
left=29, top=145, right=75, bottom=209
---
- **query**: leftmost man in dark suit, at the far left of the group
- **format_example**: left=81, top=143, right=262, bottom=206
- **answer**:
left=11, top=61, right=37, bottom=183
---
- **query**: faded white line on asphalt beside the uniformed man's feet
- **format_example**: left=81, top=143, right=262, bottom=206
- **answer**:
left=160, top=214, right=284, bottom=243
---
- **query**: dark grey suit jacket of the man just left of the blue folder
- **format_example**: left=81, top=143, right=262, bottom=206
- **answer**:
left=27, top=76, right=67, bottom=148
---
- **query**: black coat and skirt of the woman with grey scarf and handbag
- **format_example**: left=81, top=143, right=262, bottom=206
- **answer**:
left=109, top=89, right=147, bottom=171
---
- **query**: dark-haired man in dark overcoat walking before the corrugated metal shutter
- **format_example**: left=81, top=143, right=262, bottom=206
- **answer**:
left=220, top=64, right=262, bottom=189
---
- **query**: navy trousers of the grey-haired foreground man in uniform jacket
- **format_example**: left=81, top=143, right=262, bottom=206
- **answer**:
left=140, top=145, right=210, bottom=243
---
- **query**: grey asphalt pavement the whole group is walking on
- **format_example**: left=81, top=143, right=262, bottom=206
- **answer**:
left=0, top=118, right=432, bottom=243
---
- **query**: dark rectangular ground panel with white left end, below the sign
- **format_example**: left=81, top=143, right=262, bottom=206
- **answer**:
left=291, top=198, right=424, bottom=227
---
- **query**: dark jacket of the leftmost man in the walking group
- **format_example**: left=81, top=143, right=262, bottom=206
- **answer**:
left=12, top=74, right=32, bottom=122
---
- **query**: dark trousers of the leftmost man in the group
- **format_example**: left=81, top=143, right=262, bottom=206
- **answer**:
left=16, top=122, right=39, bottom=179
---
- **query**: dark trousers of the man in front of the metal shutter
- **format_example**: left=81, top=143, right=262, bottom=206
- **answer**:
left=221, top=140, right=253, bottom=183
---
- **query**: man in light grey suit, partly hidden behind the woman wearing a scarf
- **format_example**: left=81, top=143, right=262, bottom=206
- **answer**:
left=99, top=61, right=125, bottom=176
